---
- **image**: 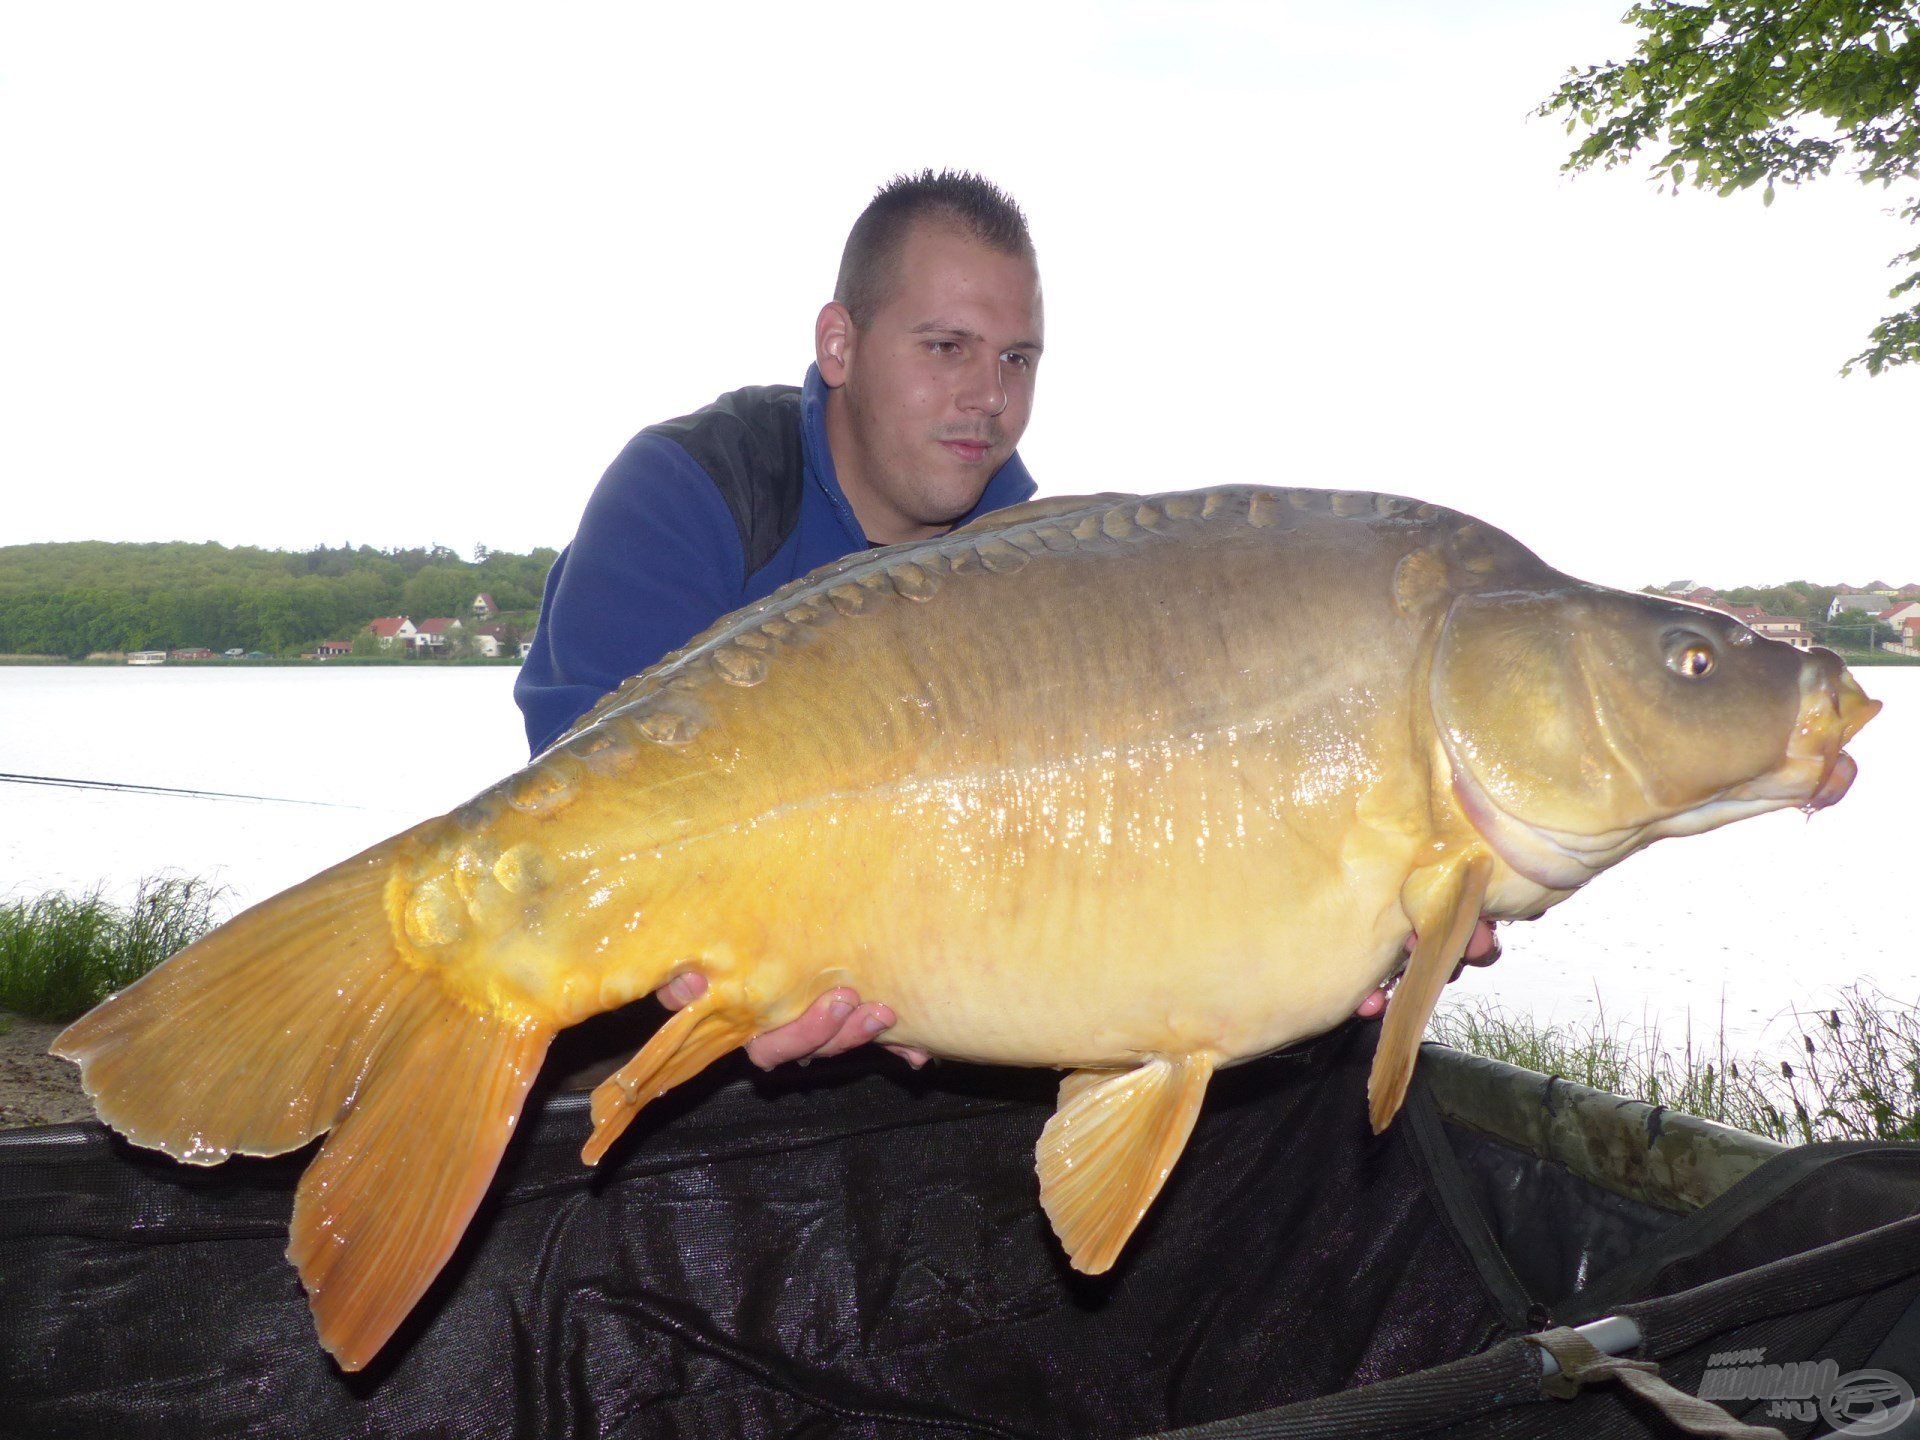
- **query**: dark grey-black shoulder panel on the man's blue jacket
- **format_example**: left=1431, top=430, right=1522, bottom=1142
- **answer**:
left=643, top=386, right=804, bottom=576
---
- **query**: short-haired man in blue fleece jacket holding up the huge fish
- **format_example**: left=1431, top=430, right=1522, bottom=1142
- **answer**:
left=515, top=171, right=1490, bottom=1068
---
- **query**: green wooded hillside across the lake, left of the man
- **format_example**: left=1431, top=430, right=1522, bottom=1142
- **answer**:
left=0, top=541, right=555, bottom=659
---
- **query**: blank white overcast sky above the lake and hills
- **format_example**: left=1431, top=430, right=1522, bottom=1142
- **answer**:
left=0, top=0, right=1920, bottom=586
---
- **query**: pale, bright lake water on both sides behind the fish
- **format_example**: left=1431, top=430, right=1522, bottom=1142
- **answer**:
left=0, top=666, right=1920, bottom=1044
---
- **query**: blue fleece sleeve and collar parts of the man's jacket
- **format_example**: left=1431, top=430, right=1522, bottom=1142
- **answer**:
left=513, top=367, right=1035, bottom=755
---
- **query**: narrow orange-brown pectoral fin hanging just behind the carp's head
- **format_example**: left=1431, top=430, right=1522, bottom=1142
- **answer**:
left=1367, top=851, right=1494, bottom=1135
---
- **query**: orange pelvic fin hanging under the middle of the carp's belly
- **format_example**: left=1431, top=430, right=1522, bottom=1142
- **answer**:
left=1037, top=1054, right=1213, bottom=1275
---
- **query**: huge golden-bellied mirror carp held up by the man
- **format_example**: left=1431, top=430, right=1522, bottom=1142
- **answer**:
left=54, top=486, right=1878, bottom=1369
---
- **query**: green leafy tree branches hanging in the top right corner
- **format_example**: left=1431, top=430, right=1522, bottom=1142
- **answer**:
left=1538, top=0, right=1920, bottom=374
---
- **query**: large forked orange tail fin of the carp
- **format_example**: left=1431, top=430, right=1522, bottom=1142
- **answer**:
left=54, top=837, right=553, bottom=1371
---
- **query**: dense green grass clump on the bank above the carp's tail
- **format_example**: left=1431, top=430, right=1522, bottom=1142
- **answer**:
left=0, top=879, right=225, bottom=1023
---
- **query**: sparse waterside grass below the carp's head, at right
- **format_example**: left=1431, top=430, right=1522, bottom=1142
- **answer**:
left=1428, top=985, right=1920, bottom=1144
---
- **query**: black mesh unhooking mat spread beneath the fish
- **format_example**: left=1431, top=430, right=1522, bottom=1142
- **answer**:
left=0, top=1023, right=1920, bottom=1440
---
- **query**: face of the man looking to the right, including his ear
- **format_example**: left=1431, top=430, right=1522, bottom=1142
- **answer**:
left=816, top=223, right=1043, bottom=541
